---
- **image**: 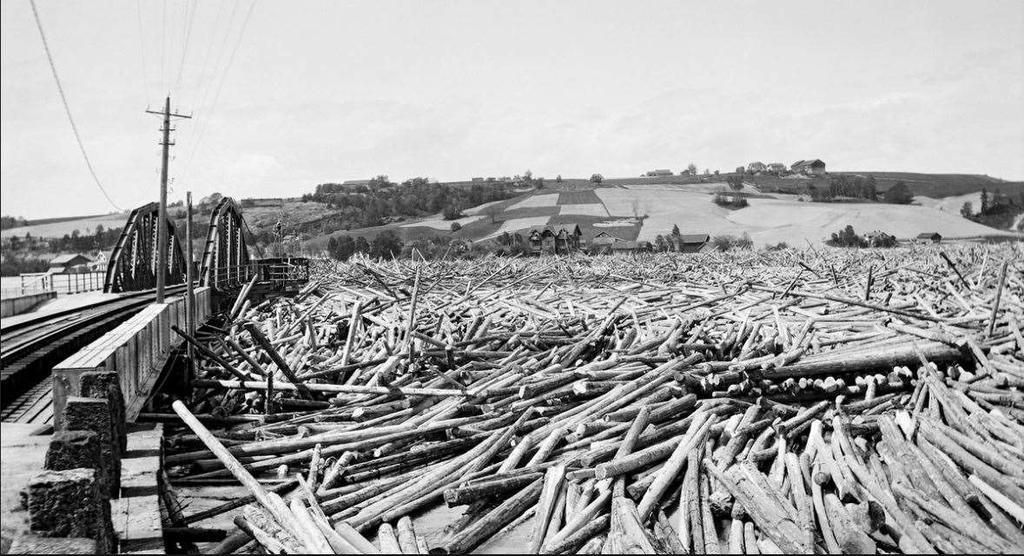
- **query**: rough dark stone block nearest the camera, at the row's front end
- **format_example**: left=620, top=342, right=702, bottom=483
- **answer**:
left=29, top=468, right=115, bottom=552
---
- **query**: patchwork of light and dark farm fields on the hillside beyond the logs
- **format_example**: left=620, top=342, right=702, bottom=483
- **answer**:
left=307, top=182, right=1021, bottom=249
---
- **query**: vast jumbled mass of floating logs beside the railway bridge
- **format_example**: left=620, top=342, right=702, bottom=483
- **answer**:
left=155, top=244, right=1024, bottom=554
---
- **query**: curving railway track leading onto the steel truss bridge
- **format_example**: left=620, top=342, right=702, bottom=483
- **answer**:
left=0, top=286, right=184, bottom=424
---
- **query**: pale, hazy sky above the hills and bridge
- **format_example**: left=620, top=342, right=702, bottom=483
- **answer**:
left=0, top=0, right=1024, bottom=218
